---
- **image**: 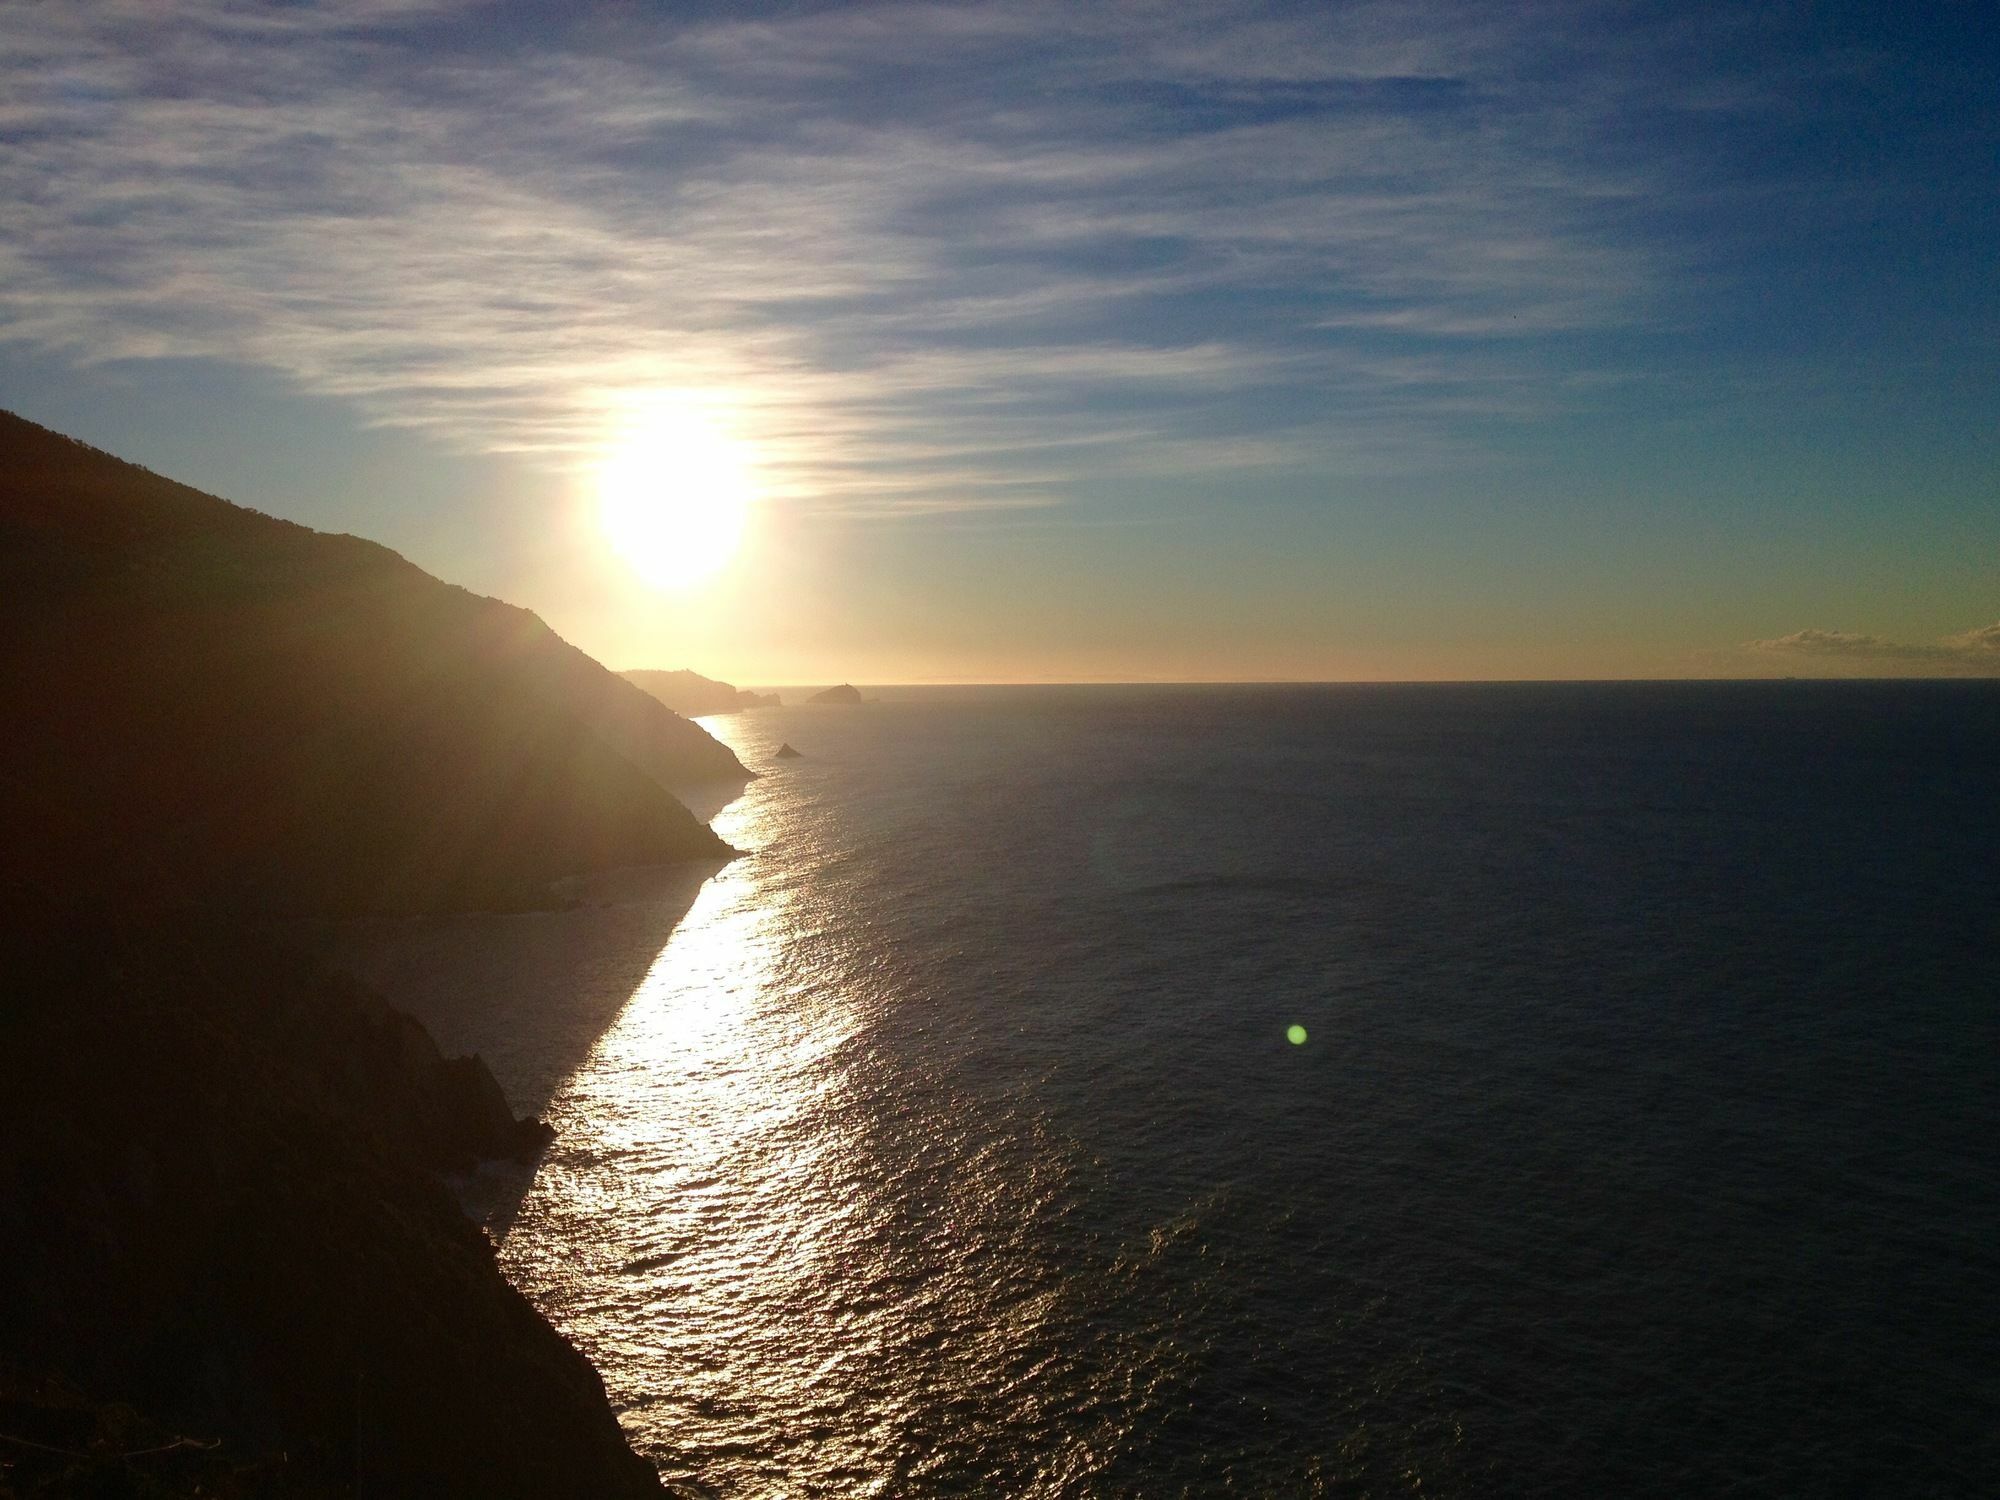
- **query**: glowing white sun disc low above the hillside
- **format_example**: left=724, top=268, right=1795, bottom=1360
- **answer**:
left=598, top=402, right=756, bottom=590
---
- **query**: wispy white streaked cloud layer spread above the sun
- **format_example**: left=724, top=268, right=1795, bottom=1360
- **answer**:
left=0, top=0, right=1784, bottom=516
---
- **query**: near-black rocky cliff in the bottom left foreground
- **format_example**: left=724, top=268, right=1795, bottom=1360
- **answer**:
left=0, top=920, right=660, bottom=1500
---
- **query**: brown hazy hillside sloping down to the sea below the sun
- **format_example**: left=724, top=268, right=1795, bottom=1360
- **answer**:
left=0, top=414, right=746, bottom=910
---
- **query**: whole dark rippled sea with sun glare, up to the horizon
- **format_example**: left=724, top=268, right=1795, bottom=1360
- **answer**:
left=340, top=682, right=2000, bottom=1496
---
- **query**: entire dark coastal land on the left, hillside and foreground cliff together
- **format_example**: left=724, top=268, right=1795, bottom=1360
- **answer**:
left=0, top=414, right=688, bottom=1500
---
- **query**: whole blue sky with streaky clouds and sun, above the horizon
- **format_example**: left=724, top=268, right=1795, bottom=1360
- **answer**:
left=0, top=0, right=2000, bottom=684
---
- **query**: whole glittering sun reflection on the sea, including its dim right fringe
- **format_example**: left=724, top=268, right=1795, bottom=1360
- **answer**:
left=486, top=714, right=1188, bottom=1496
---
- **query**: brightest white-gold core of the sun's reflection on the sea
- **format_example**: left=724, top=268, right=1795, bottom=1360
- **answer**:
left=488, top=728, right=904, bottom=1482
